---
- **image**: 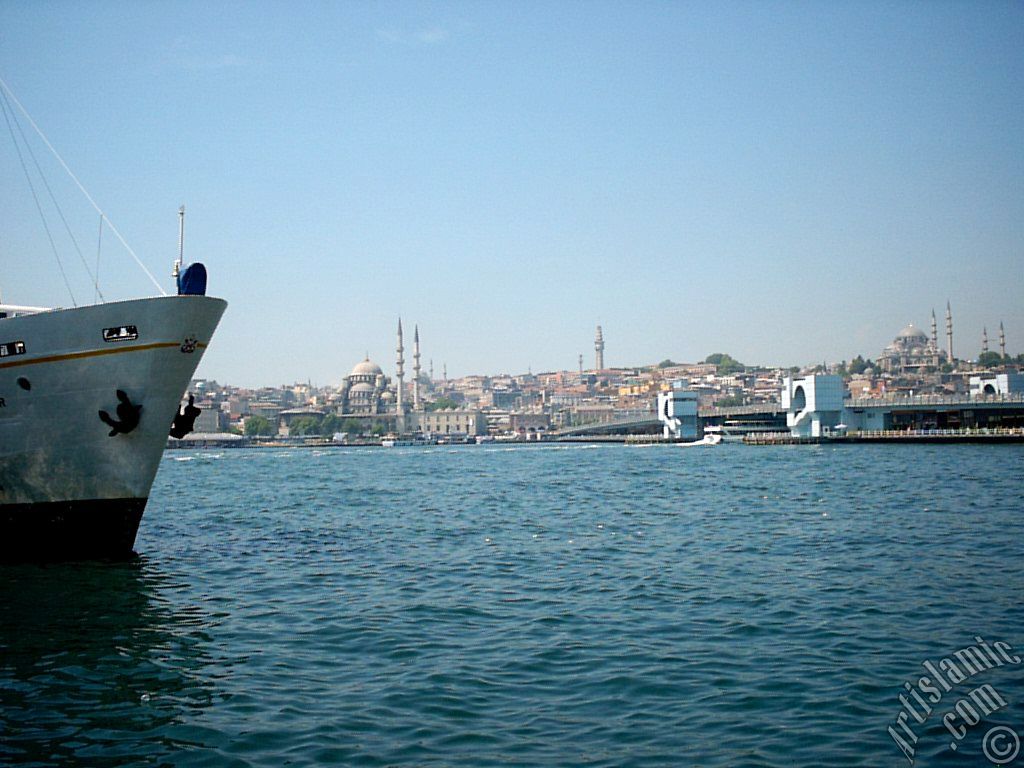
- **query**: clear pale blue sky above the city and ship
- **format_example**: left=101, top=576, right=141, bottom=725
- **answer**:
left=0, top=0, right=1024, bottom=385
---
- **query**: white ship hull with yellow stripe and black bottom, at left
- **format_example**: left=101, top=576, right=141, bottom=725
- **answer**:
left=0, top=296, right=227, bottom=559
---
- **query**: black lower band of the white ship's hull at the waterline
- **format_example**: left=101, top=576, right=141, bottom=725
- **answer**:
left=0, top=499, right=147, bottom=562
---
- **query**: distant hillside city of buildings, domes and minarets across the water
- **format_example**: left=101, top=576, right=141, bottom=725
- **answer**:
left=180, top=324, right=1024, bottom=437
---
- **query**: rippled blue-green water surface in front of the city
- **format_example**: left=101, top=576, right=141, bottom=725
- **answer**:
left=0, top=445, right=1024, bottom=767
